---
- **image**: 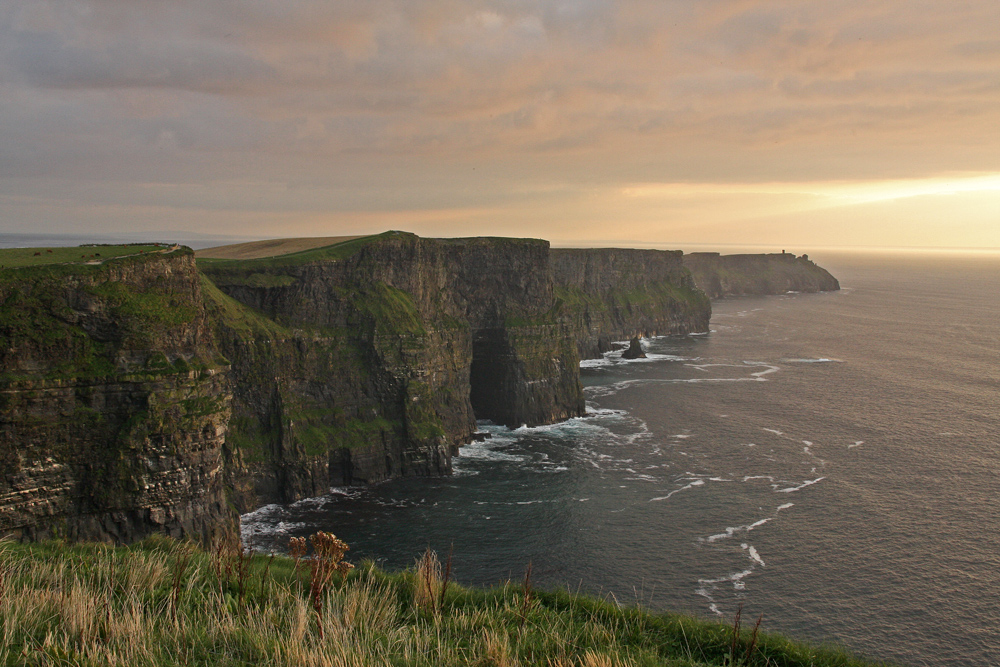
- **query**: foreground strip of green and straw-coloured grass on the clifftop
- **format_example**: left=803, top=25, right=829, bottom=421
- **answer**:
left=0, top=538, right=892, bottom=667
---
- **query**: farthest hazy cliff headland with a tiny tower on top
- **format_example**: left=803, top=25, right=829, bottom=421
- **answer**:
left=684, top=252, right=840, bottom=299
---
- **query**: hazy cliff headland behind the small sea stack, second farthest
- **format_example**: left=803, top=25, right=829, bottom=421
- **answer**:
left=552, top=248, right=712, bottom=358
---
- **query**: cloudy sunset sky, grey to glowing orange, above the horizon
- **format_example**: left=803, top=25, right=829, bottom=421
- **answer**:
left=0, top=0, right=1000, bottom=251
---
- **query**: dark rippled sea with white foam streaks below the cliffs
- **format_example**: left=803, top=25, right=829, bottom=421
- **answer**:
left=245, top=256, right=1000, bottom=665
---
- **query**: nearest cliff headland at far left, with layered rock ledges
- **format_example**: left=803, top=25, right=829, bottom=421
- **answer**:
left=0, top=250, right=233, bottom=541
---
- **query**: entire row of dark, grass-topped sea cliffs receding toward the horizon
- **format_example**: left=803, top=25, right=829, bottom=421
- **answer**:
left=0, top=232, right=835, bottom=542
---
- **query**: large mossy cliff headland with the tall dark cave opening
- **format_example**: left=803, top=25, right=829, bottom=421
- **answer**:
left=203, top=233, right=584, bottom=505
